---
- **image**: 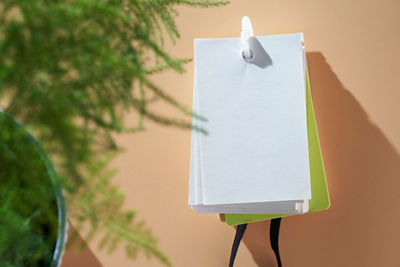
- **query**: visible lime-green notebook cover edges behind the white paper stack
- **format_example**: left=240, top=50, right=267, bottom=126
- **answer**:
left=225, top=75, right=330, bottom=225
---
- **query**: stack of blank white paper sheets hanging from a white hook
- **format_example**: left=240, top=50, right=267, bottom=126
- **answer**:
left=189, top=33, right=311, bottom=214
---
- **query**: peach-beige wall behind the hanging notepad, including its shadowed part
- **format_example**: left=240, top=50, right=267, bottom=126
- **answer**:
left=63, top=0, right=400, bottom=267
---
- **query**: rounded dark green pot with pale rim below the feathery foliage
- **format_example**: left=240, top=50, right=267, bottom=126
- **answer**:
left=0, top=110, right=68, bottom=267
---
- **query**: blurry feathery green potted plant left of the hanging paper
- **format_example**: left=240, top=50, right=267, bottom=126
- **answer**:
left=0, top=0, right=226, bottom=266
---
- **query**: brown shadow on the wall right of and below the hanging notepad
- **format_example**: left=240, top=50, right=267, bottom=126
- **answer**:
left=243, top=52, right=400, bottom=267
